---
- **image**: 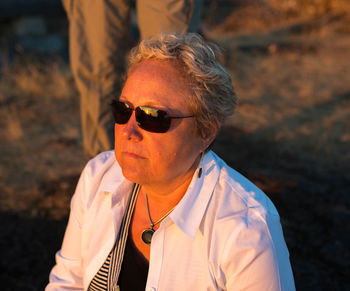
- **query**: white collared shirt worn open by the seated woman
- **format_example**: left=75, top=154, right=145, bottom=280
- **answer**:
left=46, top=151, right=295, bottom=291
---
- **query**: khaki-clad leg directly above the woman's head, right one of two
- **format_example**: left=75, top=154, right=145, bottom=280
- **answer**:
left=137, top=0, right=203, bottom=39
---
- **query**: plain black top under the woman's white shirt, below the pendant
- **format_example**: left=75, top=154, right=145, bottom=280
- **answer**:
left=118, top=233, right=149, bottom=291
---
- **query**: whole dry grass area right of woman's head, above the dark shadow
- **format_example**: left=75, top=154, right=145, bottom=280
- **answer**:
left=207, top=0, right=350, bottom=175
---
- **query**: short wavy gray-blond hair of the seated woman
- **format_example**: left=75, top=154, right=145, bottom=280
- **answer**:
left=127, top=33, right=237, bottom=138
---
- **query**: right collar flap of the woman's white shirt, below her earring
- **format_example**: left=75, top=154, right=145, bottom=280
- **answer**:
left=169, top=151, right=219, bottom=239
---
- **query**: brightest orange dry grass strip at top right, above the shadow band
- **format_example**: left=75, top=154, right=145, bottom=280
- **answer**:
left=204, top=0, right=350, bottom=35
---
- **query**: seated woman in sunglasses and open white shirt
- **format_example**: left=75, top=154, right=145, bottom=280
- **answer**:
left=46, top=34, right=295, bottom=291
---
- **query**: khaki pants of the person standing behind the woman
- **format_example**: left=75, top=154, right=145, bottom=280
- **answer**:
left=62, top=0, right=202, bottom=157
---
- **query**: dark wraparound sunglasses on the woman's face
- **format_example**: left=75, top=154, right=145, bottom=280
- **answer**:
left=111, top=100, right=193, bottom=133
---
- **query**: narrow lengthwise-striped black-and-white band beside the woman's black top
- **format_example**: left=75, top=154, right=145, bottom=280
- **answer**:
left=107, top=183, right=141, bottom=291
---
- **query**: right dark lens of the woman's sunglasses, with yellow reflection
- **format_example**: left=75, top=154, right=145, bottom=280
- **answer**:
left=135, top=107, right=171, bottom=133
